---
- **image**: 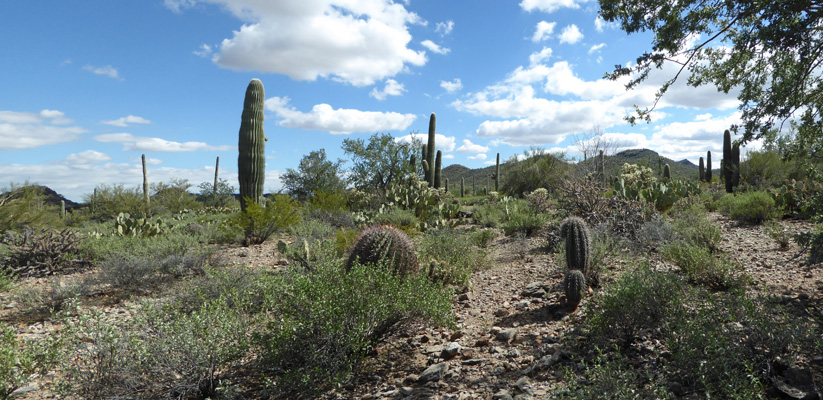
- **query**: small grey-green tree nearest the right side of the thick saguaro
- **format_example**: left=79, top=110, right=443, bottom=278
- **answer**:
left=280, top=149, right=346, bottom=201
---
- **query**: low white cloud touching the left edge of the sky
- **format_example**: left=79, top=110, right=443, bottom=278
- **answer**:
left=0, top=110, right=88, bottom=150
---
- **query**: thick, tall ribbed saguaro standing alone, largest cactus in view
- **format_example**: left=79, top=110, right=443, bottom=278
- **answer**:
left=237, top=79, right=266, bottom=211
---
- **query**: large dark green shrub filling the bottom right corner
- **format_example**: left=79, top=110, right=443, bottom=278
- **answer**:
left=665, top=291, right=820, bottom=399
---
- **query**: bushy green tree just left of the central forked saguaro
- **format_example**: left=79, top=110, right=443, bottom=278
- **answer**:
left=343, top=133, right=418, bottom=196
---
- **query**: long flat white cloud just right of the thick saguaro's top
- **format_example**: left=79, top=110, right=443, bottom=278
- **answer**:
left=266, top=97, right=417, bottom=134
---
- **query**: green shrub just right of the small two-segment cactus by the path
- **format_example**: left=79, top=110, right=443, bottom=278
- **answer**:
left=584, top=263, right=688, bottom=350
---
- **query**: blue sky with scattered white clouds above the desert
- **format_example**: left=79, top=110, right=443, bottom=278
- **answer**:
left=0, top=0, right=740, bottom=201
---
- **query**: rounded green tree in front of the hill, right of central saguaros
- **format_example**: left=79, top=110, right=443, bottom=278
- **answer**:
left=495, top=147, right=571, bottom=196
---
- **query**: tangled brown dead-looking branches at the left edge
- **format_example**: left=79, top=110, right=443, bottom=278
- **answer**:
left=0, top=228, right=83, bottom=276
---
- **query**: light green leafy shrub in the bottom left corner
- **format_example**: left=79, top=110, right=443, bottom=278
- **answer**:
left=0, top=322, right=71, bottom=400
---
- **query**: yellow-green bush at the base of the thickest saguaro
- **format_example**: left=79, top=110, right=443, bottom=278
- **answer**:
left=226, top=195, right=301, bottom=246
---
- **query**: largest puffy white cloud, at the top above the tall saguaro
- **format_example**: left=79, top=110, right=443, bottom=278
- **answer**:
left=180, top=0, right=427, bottom=86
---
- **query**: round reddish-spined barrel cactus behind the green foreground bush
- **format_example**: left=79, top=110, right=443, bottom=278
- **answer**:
left=346, top=225, right=418, bottom=275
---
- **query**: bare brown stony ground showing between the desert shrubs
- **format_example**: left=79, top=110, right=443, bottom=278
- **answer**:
left=0, top=215, right=823, bottom=400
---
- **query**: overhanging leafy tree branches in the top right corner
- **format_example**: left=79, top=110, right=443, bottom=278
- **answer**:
left=599, top=0, right=823, bottom=156
